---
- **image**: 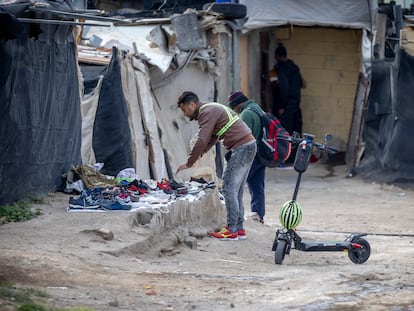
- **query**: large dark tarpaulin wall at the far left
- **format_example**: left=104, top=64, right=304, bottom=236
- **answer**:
left=0, top=24, right=81, bottom=205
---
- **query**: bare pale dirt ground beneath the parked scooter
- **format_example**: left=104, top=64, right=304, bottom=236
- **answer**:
left=0, top=164, right=414, bottom=311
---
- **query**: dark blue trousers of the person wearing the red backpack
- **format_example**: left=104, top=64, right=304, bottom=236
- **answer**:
left=247, top=155, right=266, bottom=219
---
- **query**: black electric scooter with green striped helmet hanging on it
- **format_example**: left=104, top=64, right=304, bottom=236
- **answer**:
left=272, top=133, right=371, bottom=264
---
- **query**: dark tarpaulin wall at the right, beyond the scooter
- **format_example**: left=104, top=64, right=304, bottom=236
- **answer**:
left=356, top=50, right=414, bottom=183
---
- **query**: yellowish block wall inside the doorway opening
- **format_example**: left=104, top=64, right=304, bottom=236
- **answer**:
left=274, top=27, right=362, bottom=148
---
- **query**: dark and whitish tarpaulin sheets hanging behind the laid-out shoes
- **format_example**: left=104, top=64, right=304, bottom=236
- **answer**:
left=81, top=47, right=169, bottom=180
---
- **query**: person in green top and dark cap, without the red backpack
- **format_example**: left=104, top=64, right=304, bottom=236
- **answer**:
left=227, top=91, right=266, bottom=223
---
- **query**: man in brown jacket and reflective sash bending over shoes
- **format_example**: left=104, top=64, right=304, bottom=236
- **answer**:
left=177, top=91, right=257, bottom=241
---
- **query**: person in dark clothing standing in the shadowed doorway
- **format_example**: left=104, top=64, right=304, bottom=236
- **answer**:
left=269, top=44, right=306, bottom=134
